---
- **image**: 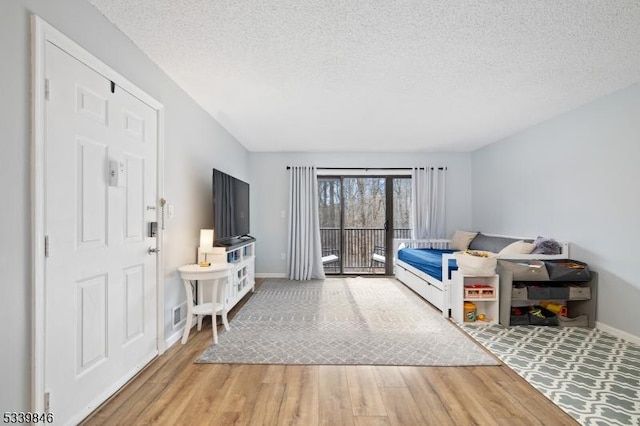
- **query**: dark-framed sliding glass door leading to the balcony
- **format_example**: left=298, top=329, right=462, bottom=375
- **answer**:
left=318, top=176, right=411, bottom=275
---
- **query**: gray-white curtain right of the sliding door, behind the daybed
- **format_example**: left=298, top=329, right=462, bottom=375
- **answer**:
left=411, top=167, right=447, bottom=239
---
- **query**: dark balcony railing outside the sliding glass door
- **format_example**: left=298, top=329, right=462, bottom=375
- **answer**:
left=320, top=228, right=411, bottom=274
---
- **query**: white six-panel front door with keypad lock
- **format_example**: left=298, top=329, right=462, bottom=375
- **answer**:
left=44, top=42, right=158, bottom=424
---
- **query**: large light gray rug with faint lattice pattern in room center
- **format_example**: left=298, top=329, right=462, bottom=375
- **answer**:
left=197, top=278, right=499, bottom=366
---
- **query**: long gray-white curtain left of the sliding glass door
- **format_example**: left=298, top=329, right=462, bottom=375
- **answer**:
left=287, top=166, right=325, bottom=280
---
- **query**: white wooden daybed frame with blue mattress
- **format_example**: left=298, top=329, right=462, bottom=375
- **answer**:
left=393, top=233, right=569, bottom=317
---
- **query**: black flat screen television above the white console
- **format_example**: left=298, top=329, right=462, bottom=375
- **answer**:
left=213, top=169, right=249, bottom=245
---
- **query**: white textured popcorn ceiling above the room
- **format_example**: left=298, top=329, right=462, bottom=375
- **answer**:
left=89, top=0, right=640, bottom=151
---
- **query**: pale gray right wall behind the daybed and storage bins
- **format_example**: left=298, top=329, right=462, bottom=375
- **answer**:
left=472, top=84, right=640, bottom=336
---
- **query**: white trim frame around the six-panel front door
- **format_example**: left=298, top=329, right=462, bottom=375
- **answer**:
left=31, top=15, right=165, bottom=412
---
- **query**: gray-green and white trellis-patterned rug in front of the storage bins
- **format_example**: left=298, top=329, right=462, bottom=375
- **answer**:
left=463, top=325, right=640, bottom=426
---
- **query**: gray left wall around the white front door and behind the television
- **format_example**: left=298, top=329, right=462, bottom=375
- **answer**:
left=0, top=0, right=249, bottom=412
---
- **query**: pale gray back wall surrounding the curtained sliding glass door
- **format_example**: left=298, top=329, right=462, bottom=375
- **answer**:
left=249, top=152, right=471, bottom=275
